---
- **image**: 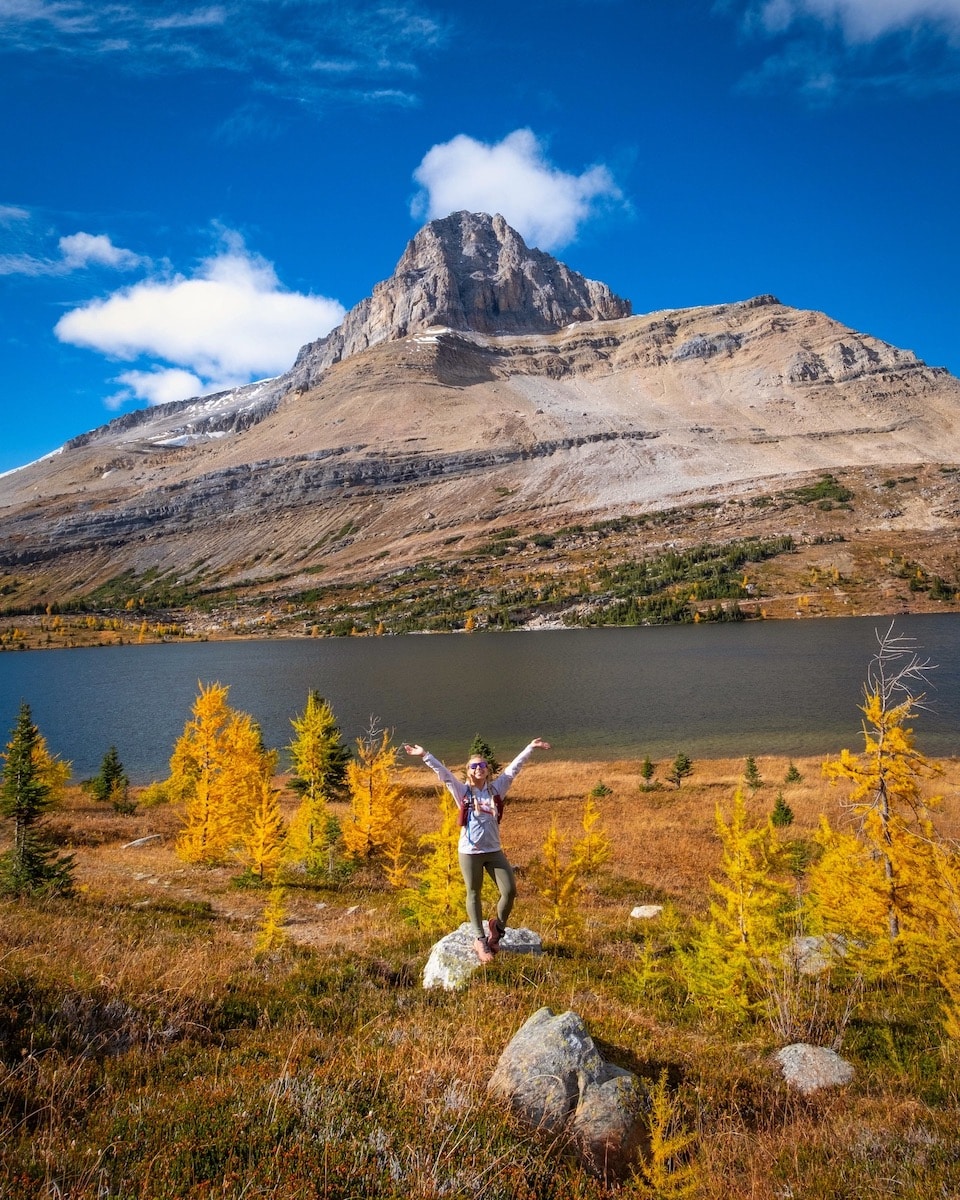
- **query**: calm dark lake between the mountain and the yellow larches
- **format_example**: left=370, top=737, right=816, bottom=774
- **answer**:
left=0, top=614, right=960, bottom=784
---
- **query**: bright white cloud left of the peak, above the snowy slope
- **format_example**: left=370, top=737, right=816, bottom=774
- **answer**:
left=54, top=235, right=344, bottom=403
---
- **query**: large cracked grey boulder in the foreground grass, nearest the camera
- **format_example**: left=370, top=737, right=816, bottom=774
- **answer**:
left=487, top=1008, right=648, bottom=1180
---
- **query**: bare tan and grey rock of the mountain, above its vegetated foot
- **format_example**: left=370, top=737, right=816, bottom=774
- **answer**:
left=0, top=215, right=960, bottom=633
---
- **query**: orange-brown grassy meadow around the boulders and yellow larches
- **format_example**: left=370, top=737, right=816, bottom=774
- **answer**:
left=0, top=748, right=960, bottom=1200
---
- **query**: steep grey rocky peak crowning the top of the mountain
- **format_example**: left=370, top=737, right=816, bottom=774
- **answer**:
left=294, top=212, right=631, bottom=386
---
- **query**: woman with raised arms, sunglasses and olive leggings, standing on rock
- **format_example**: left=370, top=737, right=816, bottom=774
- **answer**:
left=403, top=738, right=550, bottom=962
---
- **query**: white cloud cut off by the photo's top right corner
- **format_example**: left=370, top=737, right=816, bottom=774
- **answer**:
left=760, top=0, right=960, bottom=42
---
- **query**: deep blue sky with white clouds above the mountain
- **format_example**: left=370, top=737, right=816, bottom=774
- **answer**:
left=0, top=0, right=960, bottom=472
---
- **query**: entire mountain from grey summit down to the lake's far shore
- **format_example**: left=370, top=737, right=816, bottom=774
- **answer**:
left=0, top=212, right=960, bottom=628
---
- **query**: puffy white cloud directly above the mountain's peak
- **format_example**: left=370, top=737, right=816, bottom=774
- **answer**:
left=412, top=130, right=622, bottom=250
